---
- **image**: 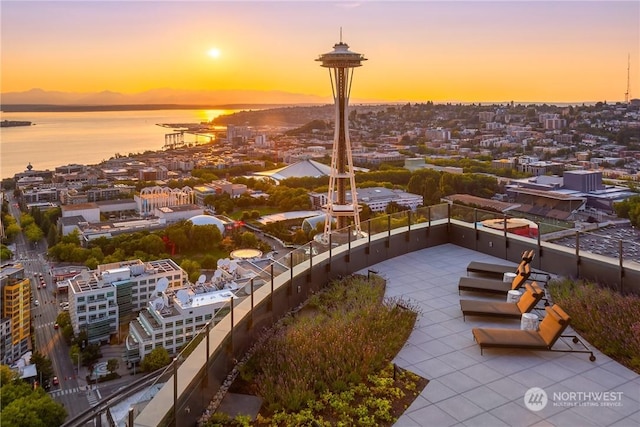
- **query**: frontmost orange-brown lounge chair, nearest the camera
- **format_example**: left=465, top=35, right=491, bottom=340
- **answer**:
left=471, top=304, right=596, bottom=362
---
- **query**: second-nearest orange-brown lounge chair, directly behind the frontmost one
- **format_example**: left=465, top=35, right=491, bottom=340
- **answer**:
left=460, top=282, right=544, bottom=320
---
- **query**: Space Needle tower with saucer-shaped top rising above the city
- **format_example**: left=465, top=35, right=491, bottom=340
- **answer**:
left=316, top=33, right=367, bottom=243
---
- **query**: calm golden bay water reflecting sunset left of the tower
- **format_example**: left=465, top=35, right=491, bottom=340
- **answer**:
left=0, top=110, right=239, bottom=178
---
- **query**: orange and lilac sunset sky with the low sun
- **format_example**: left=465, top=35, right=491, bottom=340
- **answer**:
left=1, top=0, right=640, bottom=102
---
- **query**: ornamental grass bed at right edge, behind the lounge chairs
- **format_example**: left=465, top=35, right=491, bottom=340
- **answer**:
left=549, top=279, right=640, bottom=373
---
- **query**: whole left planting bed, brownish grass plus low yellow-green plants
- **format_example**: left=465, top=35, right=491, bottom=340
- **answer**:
left=232, top=276, right=419, bottom=425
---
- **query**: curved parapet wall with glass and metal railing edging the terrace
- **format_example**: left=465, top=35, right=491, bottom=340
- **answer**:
left=91, top=204, right=640, bottom=427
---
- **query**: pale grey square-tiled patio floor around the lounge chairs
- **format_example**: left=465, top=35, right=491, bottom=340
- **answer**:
left=361, top=244, right=640, bottom=427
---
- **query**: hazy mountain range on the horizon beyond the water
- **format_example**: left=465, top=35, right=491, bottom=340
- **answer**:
left=0, top=89, right=333, bottom=106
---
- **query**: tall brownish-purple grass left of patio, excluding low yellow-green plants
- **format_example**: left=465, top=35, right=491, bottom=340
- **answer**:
left=241, top=276, right=418, bottom=420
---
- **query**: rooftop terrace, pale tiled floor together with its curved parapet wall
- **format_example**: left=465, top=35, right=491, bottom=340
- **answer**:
left=67, top=205, right=640, bottom=426
